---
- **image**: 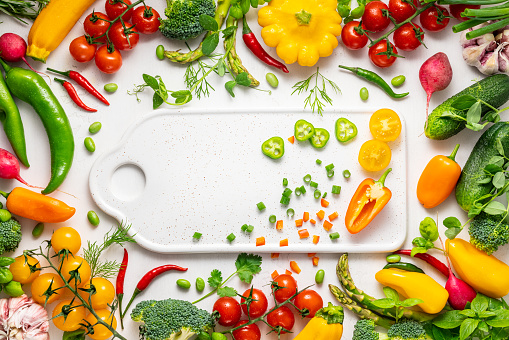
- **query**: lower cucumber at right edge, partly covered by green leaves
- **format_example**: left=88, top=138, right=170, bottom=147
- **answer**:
left=456, top=122, right=509, bottom=211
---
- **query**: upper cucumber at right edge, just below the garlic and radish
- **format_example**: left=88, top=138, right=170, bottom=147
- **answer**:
left=424, top=74, right=509, bottom=140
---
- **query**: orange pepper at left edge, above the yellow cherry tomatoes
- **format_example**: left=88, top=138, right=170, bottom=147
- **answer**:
left=0, top=187, right=76, bottom=223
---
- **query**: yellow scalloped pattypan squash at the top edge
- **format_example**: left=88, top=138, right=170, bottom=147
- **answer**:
left=258, top=0, right=341, bottom=66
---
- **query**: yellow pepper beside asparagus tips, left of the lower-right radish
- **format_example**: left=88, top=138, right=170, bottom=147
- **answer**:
left=375, top=268, right=449, bottom=314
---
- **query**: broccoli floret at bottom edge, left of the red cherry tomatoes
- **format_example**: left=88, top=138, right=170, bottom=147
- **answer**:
left=131, top=299, right=214, bottom=340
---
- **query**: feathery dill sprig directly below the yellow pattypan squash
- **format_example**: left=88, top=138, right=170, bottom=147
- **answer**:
left=292, top=67, right=341, bottom=115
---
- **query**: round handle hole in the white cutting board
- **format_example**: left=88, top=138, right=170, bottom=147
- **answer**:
left=110, top=163, right=146, bottom=201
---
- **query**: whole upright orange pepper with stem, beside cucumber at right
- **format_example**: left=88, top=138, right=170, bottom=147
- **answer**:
left=417, top=144, right=461, bottom=208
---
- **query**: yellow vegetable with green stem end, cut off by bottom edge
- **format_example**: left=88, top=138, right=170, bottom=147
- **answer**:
left=293, top=302, right=344, bottom=340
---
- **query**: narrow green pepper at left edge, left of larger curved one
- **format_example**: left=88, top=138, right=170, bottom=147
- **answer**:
left=0, top=75, right=30, bottom=167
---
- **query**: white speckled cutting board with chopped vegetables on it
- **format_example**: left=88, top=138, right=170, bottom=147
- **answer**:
left=90, top=108, right=407, bottom=253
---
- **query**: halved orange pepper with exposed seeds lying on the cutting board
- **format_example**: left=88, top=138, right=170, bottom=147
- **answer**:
left=345, top=169, right=392, bottom=234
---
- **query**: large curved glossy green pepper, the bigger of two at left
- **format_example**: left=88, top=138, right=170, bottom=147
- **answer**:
left=0, top=59, right=74, bottom=194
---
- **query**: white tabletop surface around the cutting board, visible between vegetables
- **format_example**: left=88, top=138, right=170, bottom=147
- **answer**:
left=0, top=0, right=509, bottom=339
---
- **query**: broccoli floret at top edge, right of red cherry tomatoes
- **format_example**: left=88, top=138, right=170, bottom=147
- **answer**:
left=159, top=0, right=216, bottom=40
